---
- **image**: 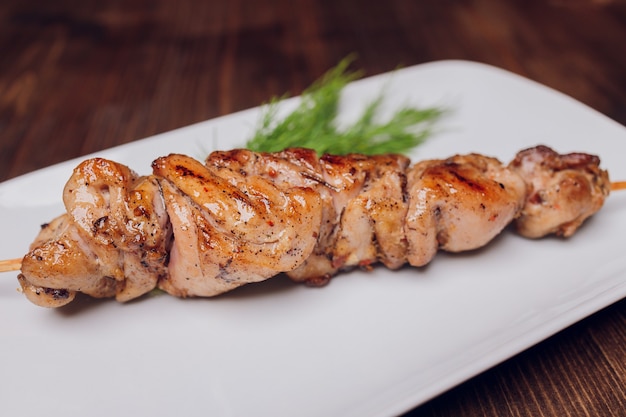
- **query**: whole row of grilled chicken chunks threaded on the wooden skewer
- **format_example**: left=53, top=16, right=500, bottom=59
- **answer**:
left=18, top=146, right=611, bottom=307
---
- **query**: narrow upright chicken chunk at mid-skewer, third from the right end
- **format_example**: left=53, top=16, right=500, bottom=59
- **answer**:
left=321, top=155, right=409, bottom=269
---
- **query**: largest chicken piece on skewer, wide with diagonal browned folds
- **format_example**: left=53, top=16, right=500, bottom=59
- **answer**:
left=153, top=155, right=321, bottom=296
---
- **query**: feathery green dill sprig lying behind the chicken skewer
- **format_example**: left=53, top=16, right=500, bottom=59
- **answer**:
left=246, top=58, right=443, bottom=155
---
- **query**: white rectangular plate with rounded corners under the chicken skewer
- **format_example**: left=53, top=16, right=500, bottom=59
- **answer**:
left=0, top=61, right=626, bottom=417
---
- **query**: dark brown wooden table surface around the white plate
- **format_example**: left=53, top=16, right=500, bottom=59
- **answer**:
left=0, top=0, right=626, bottom=417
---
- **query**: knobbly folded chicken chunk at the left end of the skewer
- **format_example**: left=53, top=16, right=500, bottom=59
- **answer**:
left=21, top=158, right=170, bottom=302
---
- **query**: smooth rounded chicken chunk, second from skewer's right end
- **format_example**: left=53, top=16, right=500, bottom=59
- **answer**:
left=404, top=154, right=526, bottom=266
